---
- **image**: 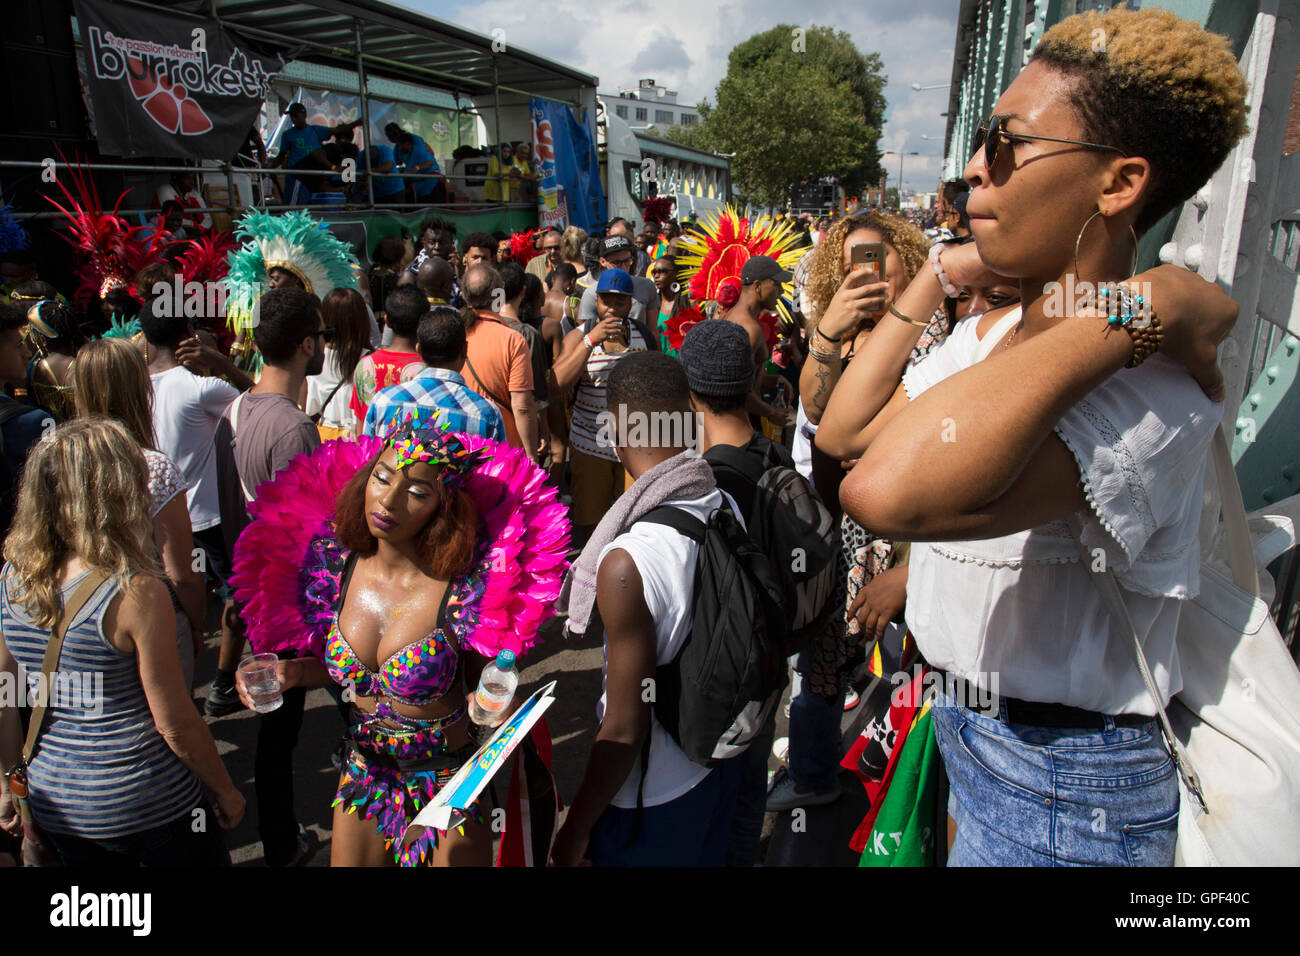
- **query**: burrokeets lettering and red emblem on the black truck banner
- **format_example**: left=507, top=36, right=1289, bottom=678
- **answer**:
left=87, top=26, right=272, bottom=137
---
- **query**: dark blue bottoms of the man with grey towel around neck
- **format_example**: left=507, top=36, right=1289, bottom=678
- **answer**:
left=586, top=757, right=741, bottom=866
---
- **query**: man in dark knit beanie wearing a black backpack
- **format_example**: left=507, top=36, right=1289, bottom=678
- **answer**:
left=681, top=320, right=836, bottom=866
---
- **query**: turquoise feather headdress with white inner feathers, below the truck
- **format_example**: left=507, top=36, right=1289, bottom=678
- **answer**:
left=225, top=209, right=360, bottom=332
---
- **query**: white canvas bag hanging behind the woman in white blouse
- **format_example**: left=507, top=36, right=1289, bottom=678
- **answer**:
left=1086, top=428, right=1300, bottom=866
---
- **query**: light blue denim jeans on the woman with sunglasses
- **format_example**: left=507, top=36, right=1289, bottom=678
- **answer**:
left=932, top=697, right=1178, bottom=866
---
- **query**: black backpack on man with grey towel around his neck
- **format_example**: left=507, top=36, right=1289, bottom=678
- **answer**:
left=638, top=503, right=787, bottom=770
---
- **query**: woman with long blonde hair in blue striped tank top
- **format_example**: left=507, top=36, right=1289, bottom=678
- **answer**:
left=0, top=418, right=244, bottom=866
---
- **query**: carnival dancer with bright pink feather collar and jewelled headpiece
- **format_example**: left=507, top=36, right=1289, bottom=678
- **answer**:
left=233, top=420, right=569, bottom=866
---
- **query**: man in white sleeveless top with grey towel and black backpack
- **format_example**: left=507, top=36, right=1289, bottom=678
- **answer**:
left=553, top=352, right=785, bottom=866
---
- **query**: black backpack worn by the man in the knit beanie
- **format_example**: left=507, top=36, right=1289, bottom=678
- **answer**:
left=705, top=444, right=842, bottom=654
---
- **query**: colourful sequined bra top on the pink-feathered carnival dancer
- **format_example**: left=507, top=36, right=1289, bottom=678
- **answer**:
left=325, top=555, right=460, bottom=708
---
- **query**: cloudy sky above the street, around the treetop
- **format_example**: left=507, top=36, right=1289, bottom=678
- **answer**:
left=390, top=0, right=959, bottom=190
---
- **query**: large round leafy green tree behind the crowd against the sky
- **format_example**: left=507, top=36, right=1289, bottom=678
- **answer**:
left=670, top=25, right=885, bottom=206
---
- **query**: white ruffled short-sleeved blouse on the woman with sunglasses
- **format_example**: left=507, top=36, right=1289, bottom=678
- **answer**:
left=904, top=313, right=1223, bottom=714
